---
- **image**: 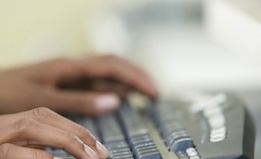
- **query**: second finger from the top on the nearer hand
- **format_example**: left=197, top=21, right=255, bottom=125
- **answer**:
left=1, top=118, right=98, bottom=159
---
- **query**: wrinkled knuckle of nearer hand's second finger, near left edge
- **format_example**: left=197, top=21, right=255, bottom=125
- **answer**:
left=13, top=118, right=36, bottom=132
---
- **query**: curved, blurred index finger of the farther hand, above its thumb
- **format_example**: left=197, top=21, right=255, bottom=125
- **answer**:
left=79, top=56, right=157, bottom=97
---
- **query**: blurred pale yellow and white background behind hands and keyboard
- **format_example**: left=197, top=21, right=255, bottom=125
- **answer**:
left=0, top=0, right=261, bottom=158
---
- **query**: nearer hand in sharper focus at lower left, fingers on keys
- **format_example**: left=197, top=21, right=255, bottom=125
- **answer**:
left=0, top=108, right=109, bottom=159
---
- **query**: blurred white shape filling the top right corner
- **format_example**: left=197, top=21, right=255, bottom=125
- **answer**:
left=205, top=0, right=261, bottom=58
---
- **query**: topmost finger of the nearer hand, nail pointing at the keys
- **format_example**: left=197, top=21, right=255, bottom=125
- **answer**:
left=25, top=108, right=109, bottom=158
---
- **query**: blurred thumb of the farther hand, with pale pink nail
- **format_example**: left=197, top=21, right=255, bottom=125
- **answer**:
left=42, top=90, right=120, bottom=115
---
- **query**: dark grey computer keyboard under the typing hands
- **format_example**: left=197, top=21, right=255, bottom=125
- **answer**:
left=47, top=93, right=255, bottom=159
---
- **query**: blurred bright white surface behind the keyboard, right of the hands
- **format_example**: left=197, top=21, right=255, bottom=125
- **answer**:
left=134, top=26, right=261, bottom=92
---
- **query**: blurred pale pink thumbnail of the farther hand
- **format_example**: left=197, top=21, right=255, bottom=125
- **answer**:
left=94, top=95, right=119, bottom=111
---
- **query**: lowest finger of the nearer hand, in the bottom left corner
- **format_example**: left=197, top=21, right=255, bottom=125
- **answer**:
left=0, top=143, right=54, bottom=159
